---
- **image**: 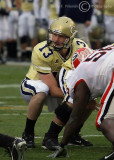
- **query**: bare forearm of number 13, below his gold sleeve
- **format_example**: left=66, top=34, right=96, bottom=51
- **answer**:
left=39, top=73, right=64, bottom=98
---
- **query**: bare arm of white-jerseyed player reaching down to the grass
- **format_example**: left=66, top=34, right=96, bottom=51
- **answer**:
left=62, top=81, right=92, bottom=145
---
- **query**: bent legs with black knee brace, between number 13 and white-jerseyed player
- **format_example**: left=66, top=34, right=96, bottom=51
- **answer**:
left=42, top=68, right=93, bottom=150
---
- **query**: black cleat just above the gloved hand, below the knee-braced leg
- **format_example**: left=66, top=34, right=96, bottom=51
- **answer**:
left=42, top=136, right=59, bottom=151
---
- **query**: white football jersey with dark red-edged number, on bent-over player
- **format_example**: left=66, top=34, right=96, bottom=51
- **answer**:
left=66, top=44, right=114, bottom=98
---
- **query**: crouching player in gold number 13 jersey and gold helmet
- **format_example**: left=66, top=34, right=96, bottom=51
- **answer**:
left=21, top=17, right=90, bottom=147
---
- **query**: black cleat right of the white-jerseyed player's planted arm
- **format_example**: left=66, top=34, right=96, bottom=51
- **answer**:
left=68, top=135, right=93, bottom=147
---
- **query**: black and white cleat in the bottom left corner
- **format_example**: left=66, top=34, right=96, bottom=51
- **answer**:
left=8, top=138, right=27, bottom=160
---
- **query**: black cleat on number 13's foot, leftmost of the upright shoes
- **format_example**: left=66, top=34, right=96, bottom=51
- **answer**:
left=22, top=132, right=35, bottom=148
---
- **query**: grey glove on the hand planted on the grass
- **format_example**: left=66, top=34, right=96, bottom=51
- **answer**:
left=47, top=146, right=69, bottom=158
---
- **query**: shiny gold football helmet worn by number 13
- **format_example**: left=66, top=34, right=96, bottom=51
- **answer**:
left=47, top=16, right=77, bottom=51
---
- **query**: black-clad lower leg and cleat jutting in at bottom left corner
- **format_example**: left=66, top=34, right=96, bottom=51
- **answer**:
left=0, top=133, right=27, bottom=160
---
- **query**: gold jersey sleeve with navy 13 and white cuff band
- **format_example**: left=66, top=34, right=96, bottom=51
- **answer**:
left=32, top=43, right=53, bottom=74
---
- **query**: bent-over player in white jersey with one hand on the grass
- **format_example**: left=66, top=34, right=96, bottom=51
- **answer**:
left=50, top=44, right=114, bottom=160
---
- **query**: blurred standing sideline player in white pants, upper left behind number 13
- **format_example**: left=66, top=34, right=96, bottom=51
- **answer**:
left=17, top=0, right=39, bottom=60
